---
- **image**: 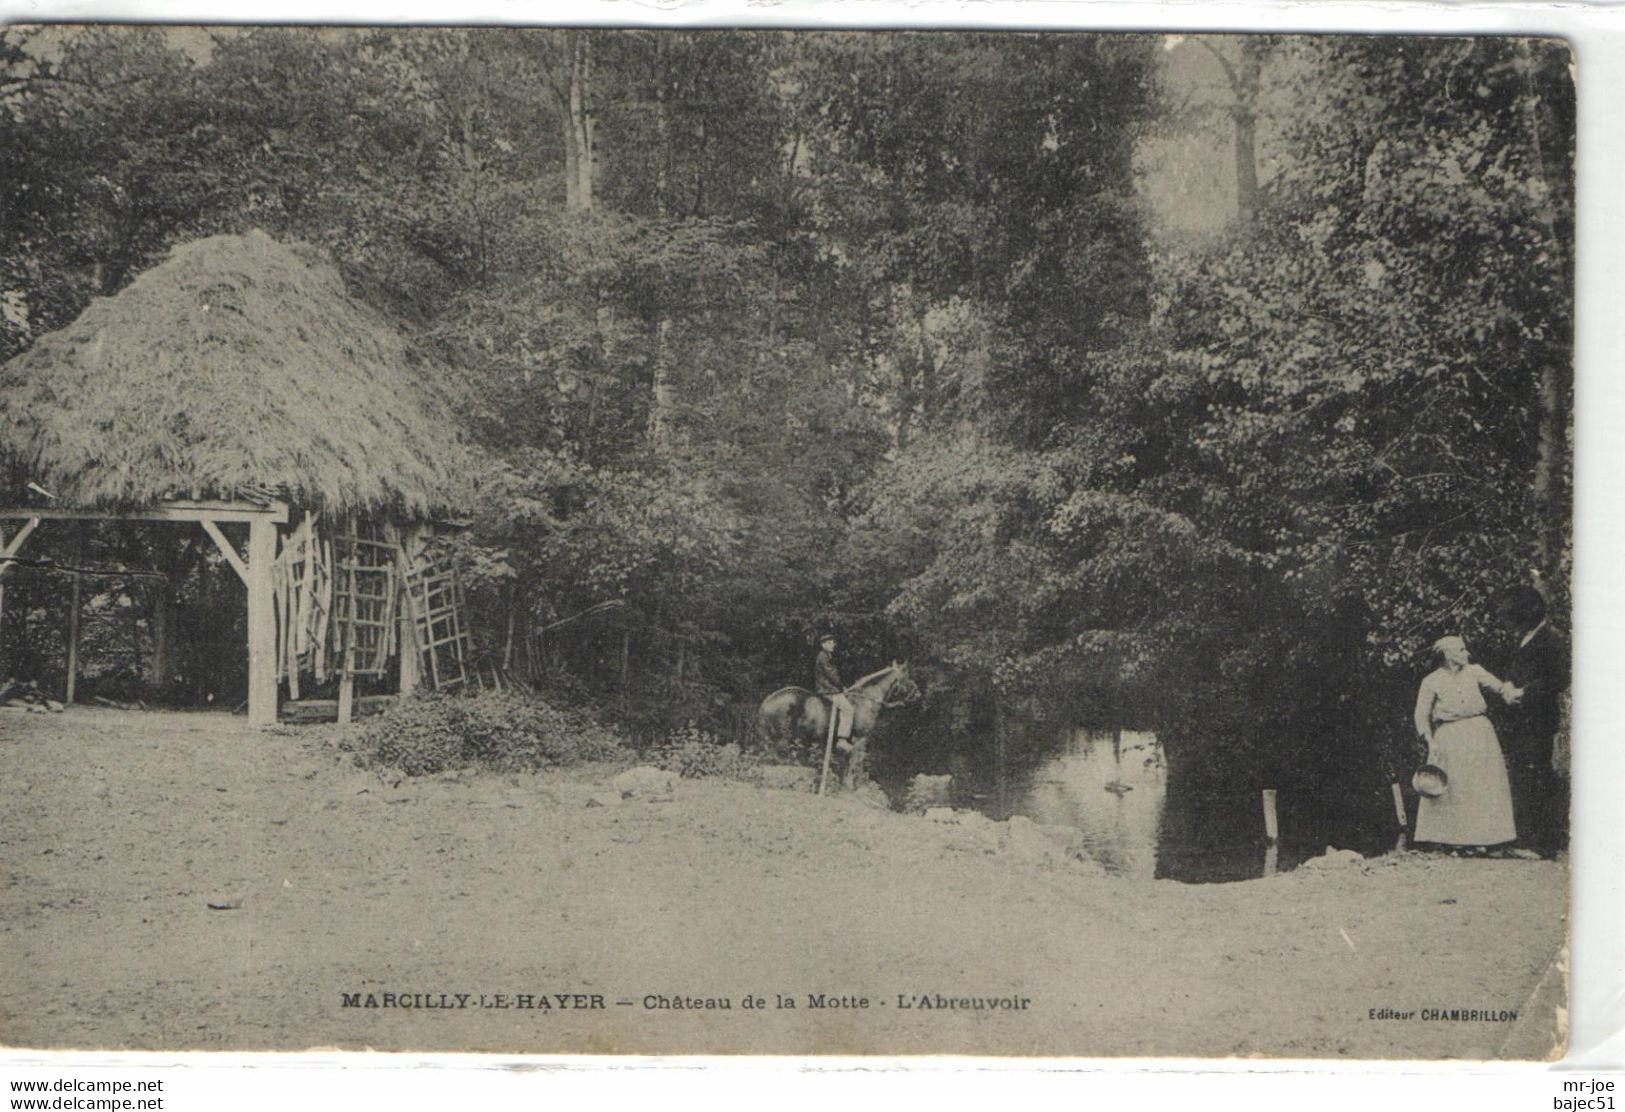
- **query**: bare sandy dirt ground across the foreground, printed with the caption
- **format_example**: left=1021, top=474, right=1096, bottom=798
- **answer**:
left=0, top=709, right=1567, bottom=1058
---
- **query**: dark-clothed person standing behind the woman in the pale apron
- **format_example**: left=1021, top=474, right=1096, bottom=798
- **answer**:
left=1502, top=587, right=1568, bottom=857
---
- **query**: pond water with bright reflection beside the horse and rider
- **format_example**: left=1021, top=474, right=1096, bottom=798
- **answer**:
left=965, top=728, right=1307, bottom=883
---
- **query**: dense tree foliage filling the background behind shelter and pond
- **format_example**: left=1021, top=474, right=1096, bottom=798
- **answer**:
left=0, top=29, right=1573, bottom=790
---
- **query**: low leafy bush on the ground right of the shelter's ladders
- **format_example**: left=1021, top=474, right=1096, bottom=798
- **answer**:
left=356, top=691, right=621, bottom=775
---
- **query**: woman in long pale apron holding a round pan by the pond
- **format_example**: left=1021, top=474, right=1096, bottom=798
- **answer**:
left=1415, top=636, right=1523, bottom=847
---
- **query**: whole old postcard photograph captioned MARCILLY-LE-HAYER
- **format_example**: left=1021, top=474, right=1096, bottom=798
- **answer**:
left=0, top=23, right=1579, bottom=1062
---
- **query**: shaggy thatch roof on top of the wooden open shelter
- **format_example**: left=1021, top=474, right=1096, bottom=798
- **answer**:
left=0, top=231, right=465, bottom=517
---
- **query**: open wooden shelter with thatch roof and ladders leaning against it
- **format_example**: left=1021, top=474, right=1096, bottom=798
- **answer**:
left=0, top=232, right=470, bottom=723
